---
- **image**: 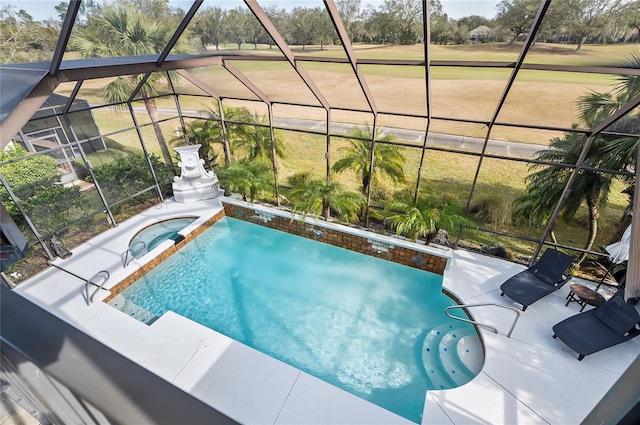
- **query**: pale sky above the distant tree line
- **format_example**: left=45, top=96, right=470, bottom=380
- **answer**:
left=5, top=0, right=499, bottom=21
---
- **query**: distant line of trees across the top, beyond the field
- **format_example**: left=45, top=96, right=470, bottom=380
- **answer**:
left=0, top=0, right=640, bottom=63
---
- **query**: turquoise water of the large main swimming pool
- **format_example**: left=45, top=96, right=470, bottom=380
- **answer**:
left=119, top=217, right=484, bottom=422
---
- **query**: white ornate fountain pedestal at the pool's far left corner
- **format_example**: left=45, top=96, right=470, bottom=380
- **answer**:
left=172, top=145, right=220, bottom=202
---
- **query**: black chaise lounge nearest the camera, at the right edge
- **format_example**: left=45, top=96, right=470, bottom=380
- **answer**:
left=553, top=289, right=640, bottom=360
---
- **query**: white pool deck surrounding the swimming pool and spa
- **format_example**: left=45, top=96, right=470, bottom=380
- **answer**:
left=15, top=200, right=640, bottom=424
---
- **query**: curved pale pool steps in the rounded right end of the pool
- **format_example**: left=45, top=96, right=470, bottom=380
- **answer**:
left=422, top=324, right=484, bottom=389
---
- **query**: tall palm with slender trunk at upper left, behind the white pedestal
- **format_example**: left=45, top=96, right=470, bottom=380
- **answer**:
left=71, top=6, right=179, bottom=165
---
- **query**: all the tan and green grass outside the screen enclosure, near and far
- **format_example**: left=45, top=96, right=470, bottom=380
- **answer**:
left=51, top=43, right=638, bottom=262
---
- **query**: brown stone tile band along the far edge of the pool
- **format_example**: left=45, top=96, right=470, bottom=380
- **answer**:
left=222, top=201, right=447, bottom=275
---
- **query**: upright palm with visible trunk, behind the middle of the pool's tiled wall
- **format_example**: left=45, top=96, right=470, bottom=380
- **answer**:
left=332, top=126, right=406, bottom=194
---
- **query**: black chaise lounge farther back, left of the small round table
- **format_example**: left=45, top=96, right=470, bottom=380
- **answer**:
left=500, top=249, right=573, bottom=311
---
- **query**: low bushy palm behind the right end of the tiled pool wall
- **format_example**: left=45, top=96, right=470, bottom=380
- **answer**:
left=384, top=196, right=475, bottom=245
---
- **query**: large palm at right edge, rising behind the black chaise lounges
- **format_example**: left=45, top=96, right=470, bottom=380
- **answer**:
left=514, top=54, right=640, bottom=264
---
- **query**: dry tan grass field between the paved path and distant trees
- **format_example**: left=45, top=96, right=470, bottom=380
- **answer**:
left=57, top=43, right=638, bottom=144
